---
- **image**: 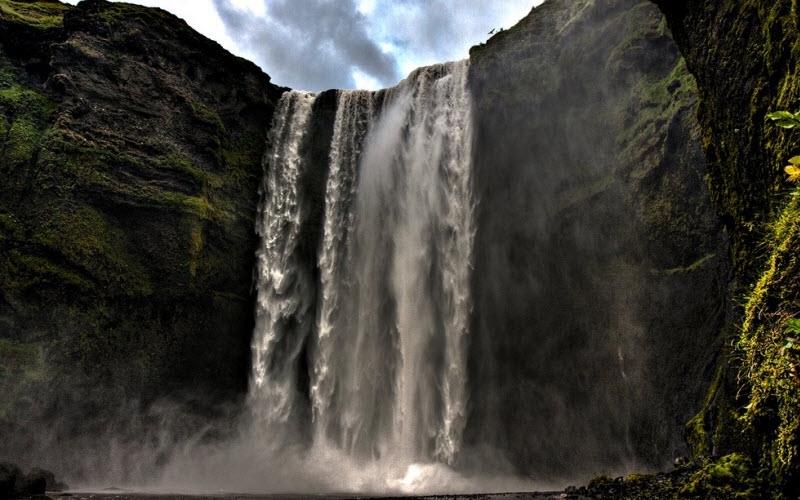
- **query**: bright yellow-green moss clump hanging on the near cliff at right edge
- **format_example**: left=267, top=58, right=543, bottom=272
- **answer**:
left=737, top=198, right=800, bottom=492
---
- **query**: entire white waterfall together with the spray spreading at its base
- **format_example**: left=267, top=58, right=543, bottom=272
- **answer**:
left=145, top=57, right=549, bottom=495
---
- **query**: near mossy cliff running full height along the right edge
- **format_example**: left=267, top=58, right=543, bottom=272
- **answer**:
left=656, top=0, right=800, bottom=496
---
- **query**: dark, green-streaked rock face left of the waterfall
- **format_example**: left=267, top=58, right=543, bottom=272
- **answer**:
left=0, top=0, right=283, bottom=470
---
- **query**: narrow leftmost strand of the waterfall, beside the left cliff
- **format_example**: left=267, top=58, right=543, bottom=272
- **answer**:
left=250, top=91, right=315, bottom=430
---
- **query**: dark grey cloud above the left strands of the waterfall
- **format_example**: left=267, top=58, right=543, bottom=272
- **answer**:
left=214, top=0, right=400, bottom=91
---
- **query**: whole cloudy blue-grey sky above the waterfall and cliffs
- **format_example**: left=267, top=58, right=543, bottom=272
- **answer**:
left=61, top=0, right=543, bottom=92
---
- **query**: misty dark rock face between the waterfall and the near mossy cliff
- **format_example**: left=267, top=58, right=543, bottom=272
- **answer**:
left=468, top=1, right=728, bottom=477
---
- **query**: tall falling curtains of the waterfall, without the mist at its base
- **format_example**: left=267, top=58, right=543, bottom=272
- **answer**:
left=251, top=61, right=474, bottom=464
